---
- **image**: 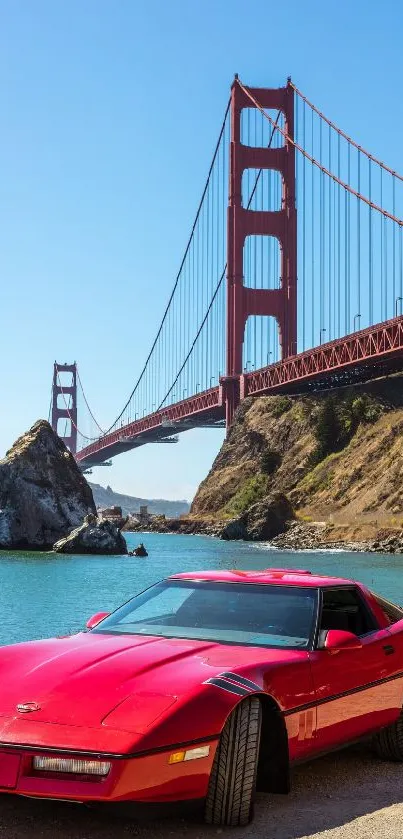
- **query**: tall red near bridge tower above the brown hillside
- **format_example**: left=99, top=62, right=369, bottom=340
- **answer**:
left=221, top=76, right=297, bottom=428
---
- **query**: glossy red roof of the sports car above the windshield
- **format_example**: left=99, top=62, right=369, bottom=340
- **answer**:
left=169, top=568, right=356, bottom=588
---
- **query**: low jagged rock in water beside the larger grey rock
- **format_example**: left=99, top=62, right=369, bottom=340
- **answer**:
left=53, top=515, right=127, bottom=556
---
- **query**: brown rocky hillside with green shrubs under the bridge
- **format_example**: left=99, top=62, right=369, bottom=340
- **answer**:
left=191, top=375, right=403, bottom=539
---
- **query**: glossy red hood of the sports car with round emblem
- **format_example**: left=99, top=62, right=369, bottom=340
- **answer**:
left=0, top=633, right=301, bottom=732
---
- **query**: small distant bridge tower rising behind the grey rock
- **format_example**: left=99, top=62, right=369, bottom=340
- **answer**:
left=52, top=361, right=77, bottom=454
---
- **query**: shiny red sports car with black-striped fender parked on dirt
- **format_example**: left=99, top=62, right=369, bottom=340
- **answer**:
left=0, top=569, right=403, bottom=825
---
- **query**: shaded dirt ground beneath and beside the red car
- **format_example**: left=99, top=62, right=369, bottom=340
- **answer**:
left=0, top=746, right=403, bottom=839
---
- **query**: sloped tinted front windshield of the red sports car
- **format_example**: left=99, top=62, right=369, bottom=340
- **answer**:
left=92, top=580, right=317, bottom=649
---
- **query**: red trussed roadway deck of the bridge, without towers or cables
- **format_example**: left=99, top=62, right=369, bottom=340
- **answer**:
left=76, top=315, right=403, bottom=471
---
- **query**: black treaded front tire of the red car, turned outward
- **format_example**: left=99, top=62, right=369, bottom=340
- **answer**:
left=204, top=697, right=262, bottom=827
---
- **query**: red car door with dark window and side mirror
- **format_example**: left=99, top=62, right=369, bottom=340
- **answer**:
left=310, top=586, right=402, bottom=751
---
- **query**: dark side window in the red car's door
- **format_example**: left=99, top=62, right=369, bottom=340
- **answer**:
left=319, top=588, right=378, bottom=636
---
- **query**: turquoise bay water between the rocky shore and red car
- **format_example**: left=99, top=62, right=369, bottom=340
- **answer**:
left=0, top=533, right=403, bottom=644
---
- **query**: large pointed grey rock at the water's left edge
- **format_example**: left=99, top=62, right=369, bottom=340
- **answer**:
left=0, top=420, right=95, bottom=550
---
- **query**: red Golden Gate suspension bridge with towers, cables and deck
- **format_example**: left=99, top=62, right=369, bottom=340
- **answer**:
left=50, top=76, right=403, bottom=470
